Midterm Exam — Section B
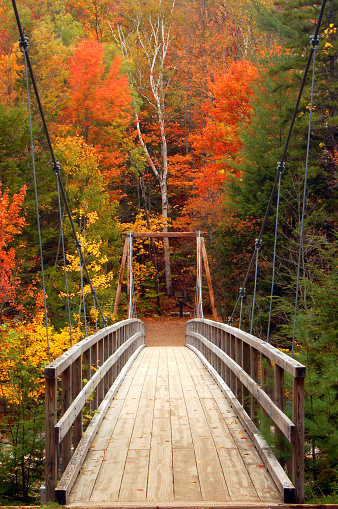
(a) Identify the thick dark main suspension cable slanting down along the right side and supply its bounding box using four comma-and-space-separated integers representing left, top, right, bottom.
228, 0, 326, 323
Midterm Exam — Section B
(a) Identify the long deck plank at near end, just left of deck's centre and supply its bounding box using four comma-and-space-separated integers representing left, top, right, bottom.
147, 418, 174, 502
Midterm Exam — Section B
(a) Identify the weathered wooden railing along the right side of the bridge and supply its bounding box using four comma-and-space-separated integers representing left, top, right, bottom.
186, 319, 306, 503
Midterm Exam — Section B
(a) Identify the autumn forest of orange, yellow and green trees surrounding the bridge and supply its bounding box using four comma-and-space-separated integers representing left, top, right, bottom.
0, 0, 338, 504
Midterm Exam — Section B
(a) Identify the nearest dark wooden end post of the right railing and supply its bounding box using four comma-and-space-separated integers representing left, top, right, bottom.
292, 377, 304, 504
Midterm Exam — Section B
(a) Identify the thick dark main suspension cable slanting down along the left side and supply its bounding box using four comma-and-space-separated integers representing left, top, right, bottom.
12, 0, 107, 325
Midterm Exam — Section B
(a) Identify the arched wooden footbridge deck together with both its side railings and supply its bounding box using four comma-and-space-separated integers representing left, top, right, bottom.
45, 318, 305, 508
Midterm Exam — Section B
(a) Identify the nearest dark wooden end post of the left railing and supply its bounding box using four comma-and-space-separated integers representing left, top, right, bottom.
45, 378, 57, 501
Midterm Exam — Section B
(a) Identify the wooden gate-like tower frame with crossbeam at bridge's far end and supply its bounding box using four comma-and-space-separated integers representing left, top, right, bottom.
114, 232, 218, 321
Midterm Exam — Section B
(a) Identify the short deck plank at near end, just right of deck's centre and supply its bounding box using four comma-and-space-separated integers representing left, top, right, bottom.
173, 448, 202, 502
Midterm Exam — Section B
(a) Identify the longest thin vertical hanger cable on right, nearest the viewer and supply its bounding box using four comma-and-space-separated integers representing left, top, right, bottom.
291, 35, 319, 357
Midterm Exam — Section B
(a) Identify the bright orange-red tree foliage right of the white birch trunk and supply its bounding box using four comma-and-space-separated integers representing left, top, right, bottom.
181, 60, 257, 229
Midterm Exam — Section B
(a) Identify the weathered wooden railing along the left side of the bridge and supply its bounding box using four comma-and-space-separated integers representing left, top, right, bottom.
45, 319, 145, 501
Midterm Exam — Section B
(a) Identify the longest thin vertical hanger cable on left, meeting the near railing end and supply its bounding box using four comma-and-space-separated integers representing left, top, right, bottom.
20, 41, 51, 362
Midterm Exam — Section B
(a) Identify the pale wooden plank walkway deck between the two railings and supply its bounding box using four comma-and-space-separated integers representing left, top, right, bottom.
68, 347, 282, 507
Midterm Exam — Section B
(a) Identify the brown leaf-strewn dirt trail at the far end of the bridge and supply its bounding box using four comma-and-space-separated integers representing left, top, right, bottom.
144, 317, 187, 346
